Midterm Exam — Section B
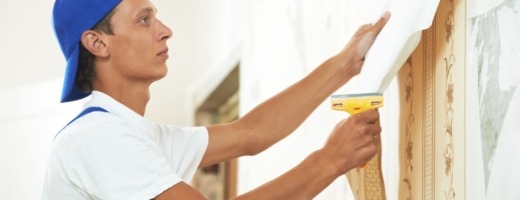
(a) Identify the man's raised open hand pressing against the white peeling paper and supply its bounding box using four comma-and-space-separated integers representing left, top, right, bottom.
335, 12, 390, 76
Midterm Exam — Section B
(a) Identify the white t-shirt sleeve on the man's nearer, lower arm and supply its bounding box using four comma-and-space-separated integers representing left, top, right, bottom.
68, 122, 182, 199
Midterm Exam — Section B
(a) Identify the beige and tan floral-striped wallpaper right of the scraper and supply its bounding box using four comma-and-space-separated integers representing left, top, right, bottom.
399, 0, 466, 199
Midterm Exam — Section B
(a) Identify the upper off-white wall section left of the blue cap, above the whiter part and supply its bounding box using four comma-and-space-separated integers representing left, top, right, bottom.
0, 0, 65, 89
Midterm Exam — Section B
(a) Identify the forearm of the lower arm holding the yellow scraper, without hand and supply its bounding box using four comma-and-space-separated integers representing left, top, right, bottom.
234, 150, 339, 200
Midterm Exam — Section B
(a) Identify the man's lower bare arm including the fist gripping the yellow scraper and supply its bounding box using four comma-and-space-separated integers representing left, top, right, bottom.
157, 111, 381, 200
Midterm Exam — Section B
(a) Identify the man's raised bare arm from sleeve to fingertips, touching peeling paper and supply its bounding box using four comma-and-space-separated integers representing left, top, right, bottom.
199, 12, 388, 167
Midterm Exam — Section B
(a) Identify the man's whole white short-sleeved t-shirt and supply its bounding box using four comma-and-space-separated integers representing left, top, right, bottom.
43, 91, 208, 199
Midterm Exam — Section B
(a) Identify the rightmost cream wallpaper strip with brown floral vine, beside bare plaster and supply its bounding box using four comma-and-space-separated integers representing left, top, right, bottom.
433, 0, 466, 200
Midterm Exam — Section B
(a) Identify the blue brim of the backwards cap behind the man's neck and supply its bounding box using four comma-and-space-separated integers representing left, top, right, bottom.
61, 45, 90, 103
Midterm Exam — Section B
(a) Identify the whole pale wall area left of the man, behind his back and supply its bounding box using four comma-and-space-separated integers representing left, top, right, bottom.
0, 0, 82, 199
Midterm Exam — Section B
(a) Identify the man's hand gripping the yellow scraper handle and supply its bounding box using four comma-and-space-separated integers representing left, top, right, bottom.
322, 110, 381, 175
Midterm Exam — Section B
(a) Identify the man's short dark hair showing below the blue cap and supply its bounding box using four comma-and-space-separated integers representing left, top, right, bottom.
74, 9, 115, 93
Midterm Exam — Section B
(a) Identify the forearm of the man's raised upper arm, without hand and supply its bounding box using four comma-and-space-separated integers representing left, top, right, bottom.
239, 57, 354, 154
